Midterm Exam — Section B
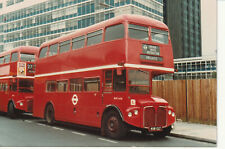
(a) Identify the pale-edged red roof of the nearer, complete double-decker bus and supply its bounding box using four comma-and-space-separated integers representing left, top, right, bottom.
41, 14, 168, 47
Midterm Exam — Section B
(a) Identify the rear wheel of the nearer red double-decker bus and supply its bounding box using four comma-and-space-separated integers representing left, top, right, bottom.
45, 104, 55, 125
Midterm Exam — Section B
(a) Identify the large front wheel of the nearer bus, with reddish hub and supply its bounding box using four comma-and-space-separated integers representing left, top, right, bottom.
103, 111, 127, 139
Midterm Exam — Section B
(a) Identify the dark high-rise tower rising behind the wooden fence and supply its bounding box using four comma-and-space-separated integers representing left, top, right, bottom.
164, 0, 202, 59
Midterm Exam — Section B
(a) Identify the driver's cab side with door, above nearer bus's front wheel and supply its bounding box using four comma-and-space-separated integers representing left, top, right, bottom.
102, 68, 126, 108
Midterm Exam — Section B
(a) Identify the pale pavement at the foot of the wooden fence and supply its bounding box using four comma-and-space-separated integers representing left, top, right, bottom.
171, 121, 217, 144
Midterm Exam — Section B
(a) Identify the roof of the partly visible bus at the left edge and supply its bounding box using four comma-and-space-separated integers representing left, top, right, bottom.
0, 46, 39, 57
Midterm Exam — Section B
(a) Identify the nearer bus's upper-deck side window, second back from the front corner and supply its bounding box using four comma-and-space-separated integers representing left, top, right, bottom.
87, 30, 102, 46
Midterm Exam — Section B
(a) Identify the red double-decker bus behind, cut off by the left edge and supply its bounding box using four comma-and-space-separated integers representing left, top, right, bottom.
0, 46, 39, 117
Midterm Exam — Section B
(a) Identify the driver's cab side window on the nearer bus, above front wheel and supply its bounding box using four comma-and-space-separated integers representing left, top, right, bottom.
113, 70, 126, 91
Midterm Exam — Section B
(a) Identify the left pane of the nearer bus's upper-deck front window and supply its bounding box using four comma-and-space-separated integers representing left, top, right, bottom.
128, 24, 149, 41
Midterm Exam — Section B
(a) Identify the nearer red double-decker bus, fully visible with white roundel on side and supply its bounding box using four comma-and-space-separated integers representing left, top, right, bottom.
33, 15, 175, 139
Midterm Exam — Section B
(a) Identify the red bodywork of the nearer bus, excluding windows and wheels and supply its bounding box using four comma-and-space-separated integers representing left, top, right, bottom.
33, 15, 175, 131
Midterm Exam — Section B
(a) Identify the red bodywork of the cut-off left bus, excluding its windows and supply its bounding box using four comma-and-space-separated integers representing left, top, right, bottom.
0, 46, 38, 112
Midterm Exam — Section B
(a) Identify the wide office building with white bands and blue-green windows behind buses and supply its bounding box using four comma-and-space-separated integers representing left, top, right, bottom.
0, 0, 163, 51
